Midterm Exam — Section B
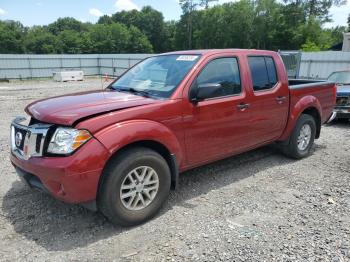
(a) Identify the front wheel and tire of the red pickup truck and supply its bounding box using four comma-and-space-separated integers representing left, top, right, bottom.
98, 147, 171, 226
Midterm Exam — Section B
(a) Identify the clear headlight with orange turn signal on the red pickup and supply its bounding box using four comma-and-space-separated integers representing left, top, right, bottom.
47, 127, 92, 155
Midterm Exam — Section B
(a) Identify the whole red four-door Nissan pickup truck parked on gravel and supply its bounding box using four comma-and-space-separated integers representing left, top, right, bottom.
11, 49, 336, 225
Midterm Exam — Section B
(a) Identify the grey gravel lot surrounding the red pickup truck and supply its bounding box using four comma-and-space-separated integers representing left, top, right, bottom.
0, 79, 350, 261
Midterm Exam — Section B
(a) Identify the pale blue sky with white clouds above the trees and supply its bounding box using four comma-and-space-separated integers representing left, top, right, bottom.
0, 0, 350, 27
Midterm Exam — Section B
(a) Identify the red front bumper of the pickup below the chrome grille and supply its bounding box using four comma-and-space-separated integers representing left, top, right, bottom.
11, 138, 109, 204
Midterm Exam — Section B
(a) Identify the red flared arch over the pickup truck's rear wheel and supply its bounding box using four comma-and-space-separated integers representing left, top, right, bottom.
279, 95, 322, 141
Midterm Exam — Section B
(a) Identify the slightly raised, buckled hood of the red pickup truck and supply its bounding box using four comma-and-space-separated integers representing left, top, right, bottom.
25, 90, 160, 126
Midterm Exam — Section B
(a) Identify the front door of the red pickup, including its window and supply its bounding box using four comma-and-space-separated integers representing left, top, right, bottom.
184, 57, 250, 166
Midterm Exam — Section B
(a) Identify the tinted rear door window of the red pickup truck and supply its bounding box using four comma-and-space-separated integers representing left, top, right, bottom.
248, 56, 278, 91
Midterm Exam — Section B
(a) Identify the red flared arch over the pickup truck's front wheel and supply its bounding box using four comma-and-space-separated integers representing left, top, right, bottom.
94, 120, 183, 163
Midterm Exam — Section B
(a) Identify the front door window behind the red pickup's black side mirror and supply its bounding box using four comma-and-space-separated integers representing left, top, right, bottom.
196, 57, 242, 98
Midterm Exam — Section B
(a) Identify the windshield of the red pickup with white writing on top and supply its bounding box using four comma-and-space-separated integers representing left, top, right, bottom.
111, 55, 200, 98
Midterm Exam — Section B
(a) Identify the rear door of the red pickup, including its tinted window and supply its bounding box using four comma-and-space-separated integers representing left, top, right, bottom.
248, 56, 289, 145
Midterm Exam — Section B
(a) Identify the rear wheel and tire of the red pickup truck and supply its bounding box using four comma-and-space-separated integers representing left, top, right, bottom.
282, 114, 316, 159
